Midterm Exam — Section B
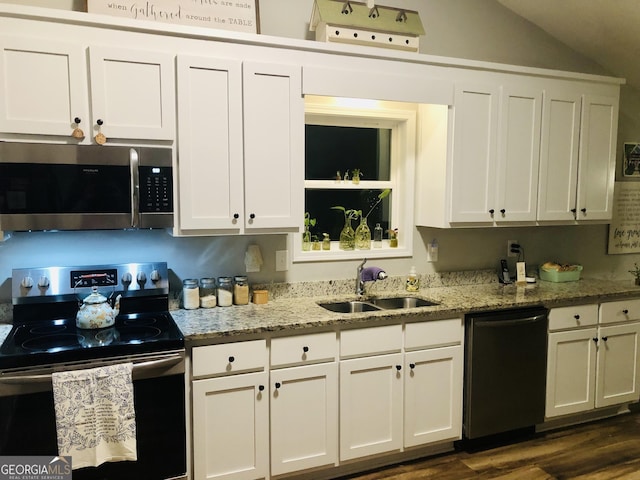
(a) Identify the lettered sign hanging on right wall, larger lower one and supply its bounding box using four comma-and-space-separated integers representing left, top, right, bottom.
608, 182, 640, 254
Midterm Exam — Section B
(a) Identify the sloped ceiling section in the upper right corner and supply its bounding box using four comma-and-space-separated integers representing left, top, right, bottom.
497, 0, 640, 90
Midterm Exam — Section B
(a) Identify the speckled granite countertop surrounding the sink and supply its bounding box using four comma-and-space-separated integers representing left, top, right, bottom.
171, 279, 640, 343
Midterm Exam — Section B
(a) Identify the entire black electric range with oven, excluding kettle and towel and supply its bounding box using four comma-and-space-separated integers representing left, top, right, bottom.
0, 262, 186, 480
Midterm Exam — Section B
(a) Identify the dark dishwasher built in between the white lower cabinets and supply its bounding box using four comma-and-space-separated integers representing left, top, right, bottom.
463, 307, 548, 440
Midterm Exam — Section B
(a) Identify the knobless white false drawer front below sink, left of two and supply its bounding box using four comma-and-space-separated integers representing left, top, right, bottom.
340, 325, 402, 358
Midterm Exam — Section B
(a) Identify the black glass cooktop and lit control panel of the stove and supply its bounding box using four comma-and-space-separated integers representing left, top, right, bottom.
0, 263, 184, 370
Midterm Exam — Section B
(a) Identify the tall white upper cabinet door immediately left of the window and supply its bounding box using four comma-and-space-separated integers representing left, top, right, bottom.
243, 62, 304, 232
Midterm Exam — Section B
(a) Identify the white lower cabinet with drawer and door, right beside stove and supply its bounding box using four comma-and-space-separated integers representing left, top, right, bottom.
192, 340, 269, 480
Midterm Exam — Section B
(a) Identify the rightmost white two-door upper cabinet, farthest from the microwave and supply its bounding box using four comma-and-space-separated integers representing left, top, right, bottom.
538, 86, 619, 223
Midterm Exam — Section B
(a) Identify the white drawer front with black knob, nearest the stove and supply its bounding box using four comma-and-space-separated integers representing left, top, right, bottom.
192, 340, 267, 377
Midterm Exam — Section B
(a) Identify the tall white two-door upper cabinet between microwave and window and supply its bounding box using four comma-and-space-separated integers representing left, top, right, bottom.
178, 55, 304, 235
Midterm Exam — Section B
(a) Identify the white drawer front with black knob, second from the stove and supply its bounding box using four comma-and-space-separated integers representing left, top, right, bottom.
271, 332, 337, 367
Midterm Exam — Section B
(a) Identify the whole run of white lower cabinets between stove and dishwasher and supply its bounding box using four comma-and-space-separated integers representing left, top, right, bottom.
192, 318, 463, 480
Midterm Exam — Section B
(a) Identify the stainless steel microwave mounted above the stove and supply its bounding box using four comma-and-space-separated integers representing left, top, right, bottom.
0, 142, 173, 231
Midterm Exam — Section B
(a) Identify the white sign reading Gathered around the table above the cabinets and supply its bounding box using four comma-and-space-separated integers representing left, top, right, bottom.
87, 0, 260, 33
